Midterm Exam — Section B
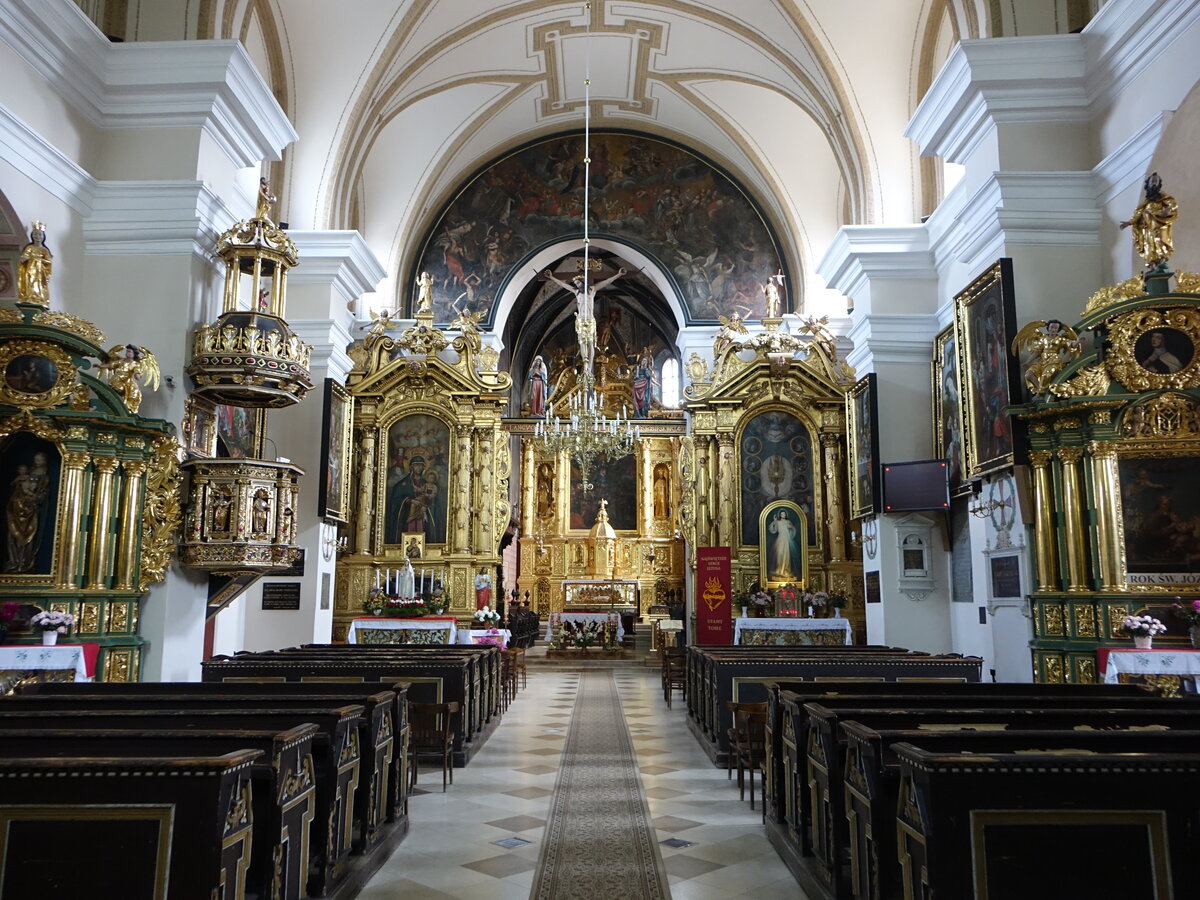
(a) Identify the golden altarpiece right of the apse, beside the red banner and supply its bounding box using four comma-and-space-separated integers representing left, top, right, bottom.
679, 318, 865, 634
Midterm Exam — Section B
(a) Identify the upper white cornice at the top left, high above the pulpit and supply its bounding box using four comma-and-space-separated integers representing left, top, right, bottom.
0, 0, 299, 168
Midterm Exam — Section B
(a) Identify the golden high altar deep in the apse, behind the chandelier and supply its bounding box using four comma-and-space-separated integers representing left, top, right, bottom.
511, 352, 685, 619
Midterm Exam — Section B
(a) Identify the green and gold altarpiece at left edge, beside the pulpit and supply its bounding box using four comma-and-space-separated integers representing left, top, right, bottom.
0, 243, 180, 694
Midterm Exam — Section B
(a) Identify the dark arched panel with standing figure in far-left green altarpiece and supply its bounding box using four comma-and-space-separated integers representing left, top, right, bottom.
0, 432, 61, 575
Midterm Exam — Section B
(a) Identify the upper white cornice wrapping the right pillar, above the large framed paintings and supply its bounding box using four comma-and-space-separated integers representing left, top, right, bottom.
905, 35, 1091, 162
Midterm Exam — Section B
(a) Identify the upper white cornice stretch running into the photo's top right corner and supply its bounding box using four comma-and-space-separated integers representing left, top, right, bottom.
1082, 0, 1200, 112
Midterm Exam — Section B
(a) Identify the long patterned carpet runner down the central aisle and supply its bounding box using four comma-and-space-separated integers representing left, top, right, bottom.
529, 671, 671, 900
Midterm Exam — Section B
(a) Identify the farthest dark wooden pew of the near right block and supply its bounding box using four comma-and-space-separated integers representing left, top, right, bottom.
763, 682, 1153, 841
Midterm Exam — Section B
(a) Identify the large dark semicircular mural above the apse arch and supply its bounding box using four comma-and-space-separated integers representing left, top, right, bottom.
409, 133, 790, 323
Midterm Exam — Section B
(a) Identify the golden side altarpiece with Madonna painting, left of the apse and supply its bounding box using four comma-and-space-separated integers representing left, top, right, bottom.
334, 308, 512, 641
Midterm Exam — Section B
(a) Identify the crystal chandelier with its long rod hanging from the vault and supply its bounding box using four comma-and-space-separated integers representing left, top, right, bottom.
534, 2, 641, 491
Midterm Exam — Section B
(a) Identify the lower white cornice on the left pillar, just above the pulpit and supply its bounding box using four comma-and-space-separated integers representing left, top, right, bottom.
83, 181, 236, 260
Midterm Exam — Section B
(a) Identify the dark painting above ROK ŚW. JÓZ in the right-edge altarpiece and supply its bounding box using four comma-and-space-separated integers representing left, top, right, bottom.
1118, 457, 1200, 575
